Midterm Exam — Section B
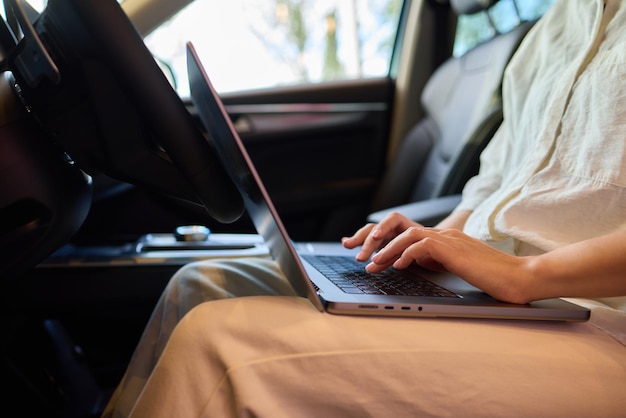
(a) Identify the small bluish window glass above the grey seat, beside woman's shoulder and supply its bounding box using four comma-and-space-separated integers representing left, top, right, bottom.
454, 0, 554, 56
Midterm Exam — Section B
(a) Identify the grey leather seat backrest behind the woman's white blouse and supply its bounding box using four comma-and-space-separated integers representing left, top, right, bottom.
372, 0, 533, 211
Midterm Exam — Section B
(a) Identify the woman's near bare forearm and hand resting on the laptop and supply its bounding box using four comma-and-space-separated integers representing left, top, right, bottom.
367, 227, 626, 303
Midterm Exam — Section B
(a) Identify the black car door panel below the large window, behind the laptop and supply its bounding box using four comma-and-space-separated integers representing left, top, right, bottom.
192, 74, 393, 240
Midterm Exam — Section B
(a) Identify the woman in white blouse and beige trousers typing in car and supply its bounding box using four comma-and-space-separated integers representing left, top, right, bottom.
106, 0, 626, 417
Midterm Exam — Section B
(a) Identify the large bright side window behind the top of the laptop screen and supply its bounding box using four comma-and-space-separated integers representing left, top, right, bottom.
145, 0, 402, 97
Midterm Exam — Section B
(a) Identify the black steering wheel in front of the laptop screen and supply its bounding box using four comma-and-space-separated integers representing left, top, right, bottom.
0, 0, 243, 223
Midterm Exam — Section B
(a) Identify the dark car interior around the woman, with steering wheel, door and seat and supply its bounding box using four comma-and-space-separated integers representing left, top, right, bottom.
0, 0, 545, 417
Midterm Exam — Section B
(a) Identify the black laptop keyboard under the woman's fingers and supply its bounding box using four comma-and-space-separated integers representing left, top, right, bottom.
302, 255, 459, 298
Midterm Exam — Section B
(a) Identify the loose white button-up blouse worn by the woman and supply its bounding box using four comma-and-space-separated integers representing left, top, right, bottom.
457, 0, 626, 342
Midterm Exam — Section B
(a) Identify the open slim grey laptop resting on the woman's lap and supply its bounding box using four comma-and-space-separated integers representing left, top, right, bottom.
187, 43, 590, 321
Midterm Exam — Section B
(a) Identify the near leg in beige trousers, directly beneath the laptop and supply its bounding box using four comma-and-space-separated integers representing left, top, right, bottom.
130, 297, 626, 417
